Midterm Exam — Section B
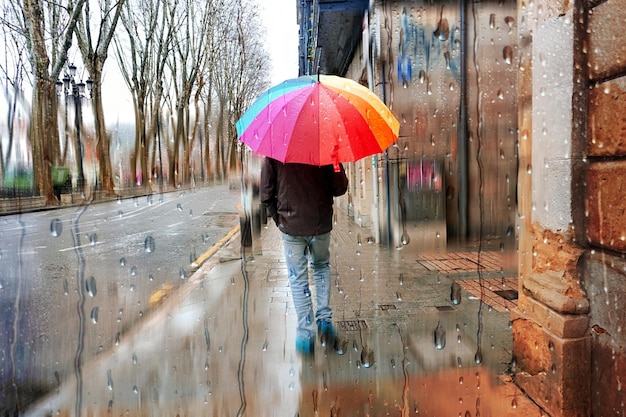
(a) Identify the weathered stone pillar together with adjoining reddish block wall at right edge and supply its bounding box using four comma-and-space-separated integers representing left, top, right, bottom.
512, 0, 626, 417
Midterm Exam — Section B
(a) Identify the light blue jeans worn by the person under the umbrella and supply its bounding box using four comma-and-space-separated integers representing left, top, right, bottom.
283, 232, 333, 337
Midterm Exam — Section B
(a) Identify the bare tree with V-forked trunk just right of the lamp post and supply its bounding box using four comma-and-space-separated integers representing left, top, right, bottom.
76, 0, 125, 195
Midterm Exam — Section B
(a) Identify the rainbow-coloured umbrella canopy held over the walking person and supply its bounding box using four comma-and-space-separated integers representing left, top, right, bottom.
237, 75, 400, 166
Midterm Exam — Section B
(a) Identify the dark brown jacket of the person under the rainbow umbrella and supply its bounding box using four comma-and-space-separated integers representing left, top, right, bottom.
260, 158, 348, 236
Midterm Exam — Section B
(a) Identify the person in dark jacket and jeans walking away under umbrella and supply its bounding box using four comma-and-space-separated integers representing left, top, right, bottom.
260, 157, 348, 355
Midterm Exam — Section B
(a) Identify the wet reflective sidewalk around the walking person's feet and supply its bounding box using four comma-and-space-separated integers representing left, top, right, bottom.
24, 206, 545, 417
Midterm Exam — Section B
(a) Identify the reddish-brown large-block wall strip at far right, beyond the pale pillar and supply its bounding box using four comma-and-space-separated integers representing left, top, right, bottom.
575, 0, 626, 416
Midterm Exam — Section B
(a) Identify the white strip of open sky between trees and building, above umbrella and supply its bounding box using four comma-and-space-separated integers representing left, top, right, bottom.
260, 0, 298, 85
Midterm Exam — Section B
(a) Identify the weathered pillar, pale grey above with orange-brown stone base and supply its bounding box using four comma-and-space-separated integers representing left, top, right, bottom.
511, 1, 591, 417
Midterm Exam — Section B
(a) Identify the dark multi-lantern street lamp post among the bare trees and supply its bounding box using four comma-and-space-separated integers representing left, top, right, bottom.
56, 64, 93, 194
